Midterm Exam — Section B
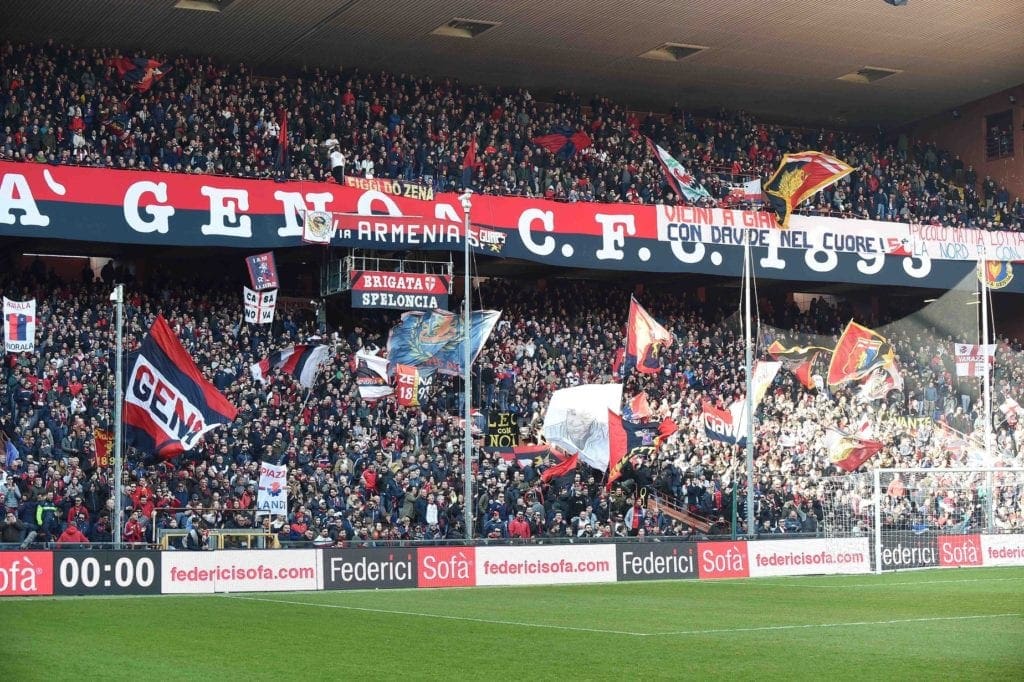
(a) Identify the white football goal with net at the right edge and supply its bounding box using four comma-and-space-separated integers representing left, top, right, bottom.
819, 468, 1024, 573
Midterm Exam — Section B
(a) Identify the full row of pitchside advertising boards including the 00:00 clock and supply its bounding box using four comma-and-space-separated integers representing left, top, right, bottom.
0, 534, 1024, 597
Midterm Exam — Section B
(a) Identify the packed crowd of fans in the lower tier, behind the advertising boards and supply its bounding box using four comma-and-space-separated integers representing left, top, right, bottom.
0, 260, 1024, 545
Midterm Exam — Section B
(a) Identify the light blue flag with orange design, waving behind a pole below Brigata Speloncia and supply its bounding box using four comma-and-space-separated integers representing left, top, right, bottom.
387, 310, 502, 375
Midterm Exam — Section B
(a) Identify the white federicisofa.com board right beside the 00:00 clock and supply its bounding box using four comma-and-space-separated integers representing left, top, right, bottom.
160, 549, 324, 594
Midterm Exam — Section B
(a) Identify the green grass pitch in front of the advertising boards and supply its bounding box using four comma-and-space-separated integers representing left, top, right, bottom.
0, 568, 1024, 681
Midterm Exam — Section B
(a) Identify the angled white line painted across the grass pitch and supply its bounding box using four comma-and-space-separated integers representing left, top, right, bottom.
222, 595, 1021, 637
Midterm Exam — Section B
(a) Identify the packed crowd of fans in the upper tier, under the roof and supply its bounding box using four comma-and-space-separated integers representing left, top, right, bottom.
0, 43, 1024, 230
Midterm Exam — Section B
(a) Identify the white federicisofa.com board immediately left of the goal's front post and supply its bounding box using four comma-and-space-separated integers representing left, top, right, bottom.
746, 538, 871, 578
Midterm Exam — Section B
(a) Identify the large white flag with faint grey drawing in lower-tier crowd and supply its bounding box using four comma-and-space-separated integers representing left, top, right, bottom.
543, 384, 623, 471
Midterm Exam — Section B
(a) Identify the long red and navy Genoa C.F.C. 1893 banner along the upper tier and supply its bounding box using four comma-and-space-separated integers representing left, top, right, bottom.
0, 162, 1024, 293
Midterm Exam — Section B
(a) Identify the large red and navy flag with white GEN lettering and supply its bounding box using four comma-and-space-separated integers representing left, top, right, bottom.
124, 315, 238, 460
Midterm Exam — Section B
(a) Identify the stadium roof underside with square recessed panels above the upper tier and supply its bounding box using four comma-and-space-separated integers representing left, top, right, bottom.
4, 0, 1024, 126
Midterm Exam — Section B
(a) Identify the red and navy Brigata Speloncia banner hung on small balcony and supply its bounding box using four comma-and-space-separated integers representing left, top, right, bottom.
350, 270, 451, 310
